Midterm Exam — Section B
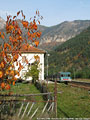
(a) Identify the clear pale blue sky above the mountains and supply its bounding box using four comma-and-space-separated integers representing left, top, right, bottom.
0, 0, 90, 26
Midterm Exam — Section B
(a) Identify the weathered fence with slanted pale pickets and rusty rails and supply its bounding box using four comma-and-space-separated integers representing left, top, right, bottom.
0, 79, 57, 120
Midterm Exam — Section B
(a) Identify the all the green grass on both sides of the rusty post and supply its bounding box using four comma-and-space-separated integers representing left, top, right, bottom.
2, 83, 90, 120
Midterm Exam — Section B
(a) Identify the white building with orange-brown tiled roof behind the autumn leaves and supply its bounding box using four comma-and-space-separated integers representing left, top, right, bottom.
15, 46, 45, 80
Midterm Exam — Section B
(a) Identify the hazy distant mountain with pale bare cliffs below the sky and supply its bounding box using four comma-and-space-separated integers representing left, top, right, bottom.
40, 20, 90, 50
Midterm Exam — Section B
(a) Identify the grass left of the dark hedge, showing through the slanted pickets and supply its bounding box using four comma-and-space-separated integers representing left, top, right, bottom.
0, 83, 48, 120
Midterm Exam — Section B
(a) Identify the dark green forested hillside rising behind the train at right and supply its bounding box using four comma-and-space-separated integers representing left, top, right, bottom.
45, 27, 90, 78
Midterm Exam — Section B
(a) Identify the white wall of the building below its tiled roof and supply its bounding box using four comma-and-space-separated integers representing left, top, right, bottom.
15, 53, 44, 80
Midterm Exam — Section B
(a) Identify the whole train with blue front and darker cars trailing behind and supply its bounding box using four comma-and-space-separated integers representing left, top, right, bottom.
49, 72, 72, 84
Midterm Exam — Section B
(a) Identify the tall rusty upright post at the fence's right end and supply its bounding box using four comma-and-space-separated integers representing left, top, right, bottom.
54, 77, 57, 118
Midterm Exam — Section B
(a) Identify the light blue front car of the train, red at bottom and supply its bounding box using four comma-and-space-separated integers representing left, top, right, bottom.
58, 72, 71, 83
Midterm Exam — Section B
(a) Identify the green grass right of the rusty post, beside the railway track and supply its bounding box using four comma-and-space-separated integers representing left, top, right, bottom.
48, 83, 90, 118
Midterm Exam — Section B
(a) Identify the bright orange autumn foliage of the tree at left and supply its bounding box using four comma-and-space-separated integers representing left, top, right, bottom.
0, 10, 42, 90
